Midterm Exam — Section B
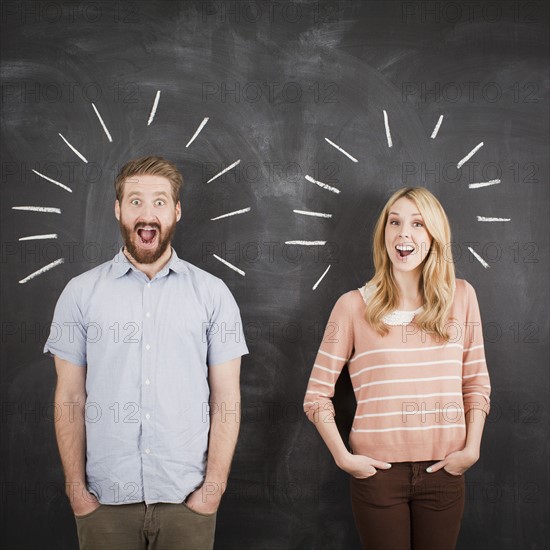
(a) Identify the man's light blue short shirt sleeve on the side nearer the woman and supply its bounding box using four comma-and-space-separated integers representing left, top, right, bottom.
206, 280, 248, 367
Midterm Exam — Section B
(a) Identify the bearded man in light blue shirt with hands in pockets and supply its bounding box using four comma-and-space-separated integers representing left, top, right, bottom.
44, 157, 248, 550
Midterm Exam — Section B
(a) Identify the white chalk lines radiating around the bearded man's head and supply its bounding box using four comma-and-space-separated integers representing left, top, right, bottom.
12, 90, 252, 284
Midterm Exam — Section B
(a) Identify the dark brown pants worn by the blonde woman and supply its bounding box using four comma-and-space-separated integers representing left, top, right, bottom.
351, 460, 465, 550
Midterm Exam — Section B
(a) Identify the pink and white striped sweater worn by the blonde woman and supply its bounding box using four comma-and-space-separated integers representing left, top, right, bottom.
304, 279, 490, 462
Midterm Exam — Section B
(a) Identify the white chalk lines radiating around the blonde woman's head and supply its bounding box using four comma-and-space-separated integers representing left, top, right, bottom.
292, 109, 511, 290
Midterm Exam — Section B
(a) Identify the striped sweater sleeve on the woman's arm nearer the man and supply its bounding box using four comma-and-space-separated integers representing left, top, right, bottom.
304, 293, 353, 421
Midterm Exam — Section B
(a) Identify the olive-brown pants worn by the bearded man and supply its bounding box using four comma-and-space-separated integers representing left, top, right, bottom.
75, 502, 216, 550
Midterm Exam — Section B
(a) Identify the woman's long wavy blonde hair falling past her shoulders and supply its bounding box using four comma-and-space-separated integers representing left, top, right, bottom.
365, 187, 455, 342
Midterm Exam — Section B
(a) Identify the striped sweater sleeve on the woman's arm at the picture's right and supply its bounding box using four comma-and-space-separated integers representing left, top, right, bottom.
462, 281, 491, 415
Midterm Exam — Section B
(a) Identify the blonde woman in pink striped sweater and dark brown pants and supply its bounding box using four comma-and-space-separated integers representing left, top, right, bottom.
304, 187, 490, 550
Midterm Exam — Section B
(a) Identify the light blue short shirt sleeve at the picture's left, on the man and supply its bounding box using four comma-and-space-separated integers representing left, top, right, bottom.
43, 280, 86, 367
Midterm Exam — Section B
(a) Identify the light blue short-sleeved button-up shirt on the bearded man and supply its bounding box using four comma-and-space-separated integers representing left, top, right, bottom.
44, 248, 248, 504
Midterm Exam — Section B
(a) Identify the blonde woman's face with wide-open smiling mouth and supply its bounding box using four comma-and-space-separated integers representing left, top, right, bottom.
385, 197, 432, 272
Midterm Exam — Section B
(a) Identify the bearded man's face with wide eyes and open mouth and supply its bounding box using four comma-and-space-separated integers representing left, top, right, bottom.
115, 175, 181, 264
